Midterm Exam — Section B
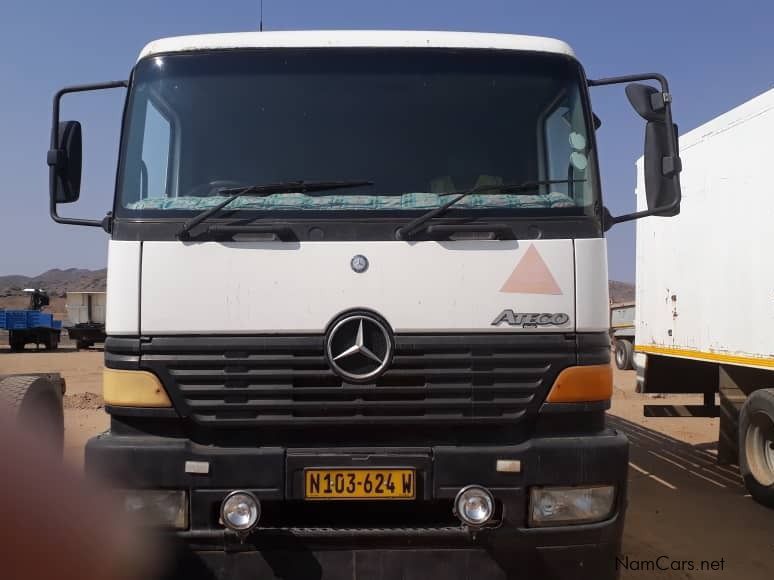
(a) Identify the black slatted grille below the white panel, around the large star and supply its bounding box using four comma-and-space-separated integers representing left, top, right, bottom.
140, 335, 575, 426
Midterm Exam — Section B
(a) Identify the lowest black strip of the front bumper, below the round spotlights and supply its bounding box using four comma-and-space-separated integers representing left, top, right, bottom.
166, 543, 619, 580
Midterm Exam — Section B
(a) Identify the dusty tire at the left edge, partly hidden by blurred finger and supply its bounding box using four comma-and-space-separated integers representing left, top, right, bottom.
0, 375, 64, 456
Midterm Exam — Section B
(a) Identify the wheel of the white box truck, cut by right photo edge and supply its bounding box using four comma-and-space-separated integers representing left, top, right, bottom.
739, 389, 774, 508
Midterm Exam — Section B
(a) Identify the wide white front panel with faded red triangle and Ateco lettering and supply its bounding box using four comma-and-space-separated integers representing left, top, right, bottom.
139, 240, 580, 335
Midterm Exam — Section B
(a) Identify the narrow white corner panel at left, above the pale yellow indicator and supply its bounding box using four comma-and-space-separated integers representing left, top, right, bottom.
105, 240, 142, 336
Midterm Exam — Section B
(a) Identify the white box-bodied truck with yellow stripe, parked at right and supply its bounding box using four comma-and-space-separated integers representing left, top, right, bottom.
635, 90, 774, 507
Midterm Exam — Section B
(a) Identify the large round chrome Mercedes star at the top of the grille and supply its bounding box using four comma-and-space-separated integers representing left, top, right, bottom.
325, 314, 392, 382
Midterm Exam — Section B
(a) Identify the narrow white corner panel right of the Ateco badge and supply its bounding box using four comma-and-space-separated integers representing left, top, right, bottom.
575, 238, 610, 332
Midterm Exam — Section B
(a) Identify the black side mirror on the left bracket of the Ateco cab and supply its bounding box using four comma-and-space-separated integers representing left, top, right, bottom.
46, 121, 83, 203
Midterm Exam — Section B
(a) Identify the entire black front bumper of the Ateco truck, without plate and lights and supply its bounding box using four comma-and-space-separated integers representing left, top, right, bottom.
86, 431, 628, 580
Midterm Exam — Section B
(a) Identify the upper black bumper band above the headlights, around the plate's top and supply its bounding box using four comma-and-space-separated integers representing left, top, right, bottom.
85, 431, 628, 499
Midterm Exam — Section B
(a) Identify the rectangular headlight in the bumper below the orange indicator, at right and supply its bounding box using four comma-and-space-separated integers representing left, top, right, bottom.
529, 485, 615, 527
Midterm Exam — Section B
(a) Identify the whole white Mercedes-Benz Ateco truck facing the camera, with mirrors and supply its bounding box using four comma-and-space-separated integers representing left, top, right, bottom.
48, 31, 679, 580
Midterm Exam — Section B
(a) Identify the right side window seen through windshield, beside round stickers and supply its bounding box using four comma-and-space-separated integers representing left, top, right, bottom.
543, 88, 591, 206
